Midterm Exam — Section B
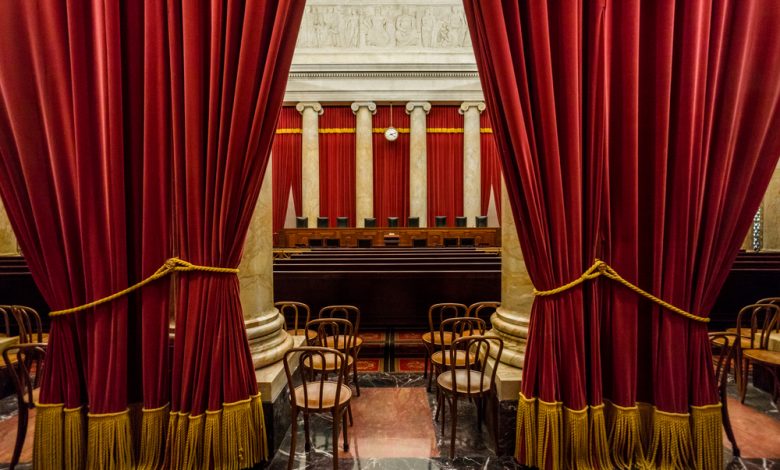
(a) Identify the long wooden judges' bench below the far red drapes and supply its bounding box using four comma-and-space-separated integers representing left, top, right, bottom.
277, 227, 501, 248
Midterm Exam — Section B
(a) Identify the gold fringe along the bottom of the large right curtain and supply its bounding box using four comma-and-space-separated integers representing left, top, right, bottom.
515, 393, 723, 470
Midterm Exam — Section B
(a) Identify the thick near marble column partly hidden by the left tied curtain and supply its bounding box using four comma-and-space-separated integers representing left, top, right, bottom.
238, 160, 293, 369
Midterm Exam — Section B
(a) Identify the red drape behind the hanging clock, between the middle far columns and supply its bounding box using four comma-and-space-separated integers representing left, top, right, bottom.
373, 105, 409, 226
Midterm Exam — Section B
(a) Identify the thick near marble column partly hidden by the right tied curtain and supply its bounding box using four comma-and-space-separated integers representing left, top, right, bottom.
490, 181, 534, 367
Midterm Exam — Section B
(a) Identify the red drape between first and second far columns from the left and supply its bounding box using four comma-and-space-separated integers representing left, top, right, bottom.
319, 106, 355, 227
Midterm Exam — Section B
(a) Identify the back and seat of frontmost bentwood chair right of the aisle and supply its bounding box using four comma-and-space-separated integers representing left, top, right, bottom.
449, 335, 504, 396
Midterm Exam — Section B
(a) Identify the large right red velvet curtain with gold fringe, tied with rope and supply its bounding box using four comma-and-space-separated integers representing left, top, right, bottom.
464, 0, 780, 468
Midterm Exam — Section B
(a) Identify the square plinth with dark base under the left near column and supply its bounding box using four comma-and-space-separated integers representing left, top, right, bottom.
255, 335, 304, 458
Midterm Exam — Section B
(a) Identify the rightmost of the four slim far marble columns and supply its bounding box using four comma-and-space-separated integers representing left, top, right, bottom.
458, 101, 485, 227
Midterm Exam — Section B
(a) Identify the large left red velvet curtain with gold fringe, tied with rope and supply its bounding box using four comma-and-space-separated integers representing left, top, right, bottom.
0, 1, 303, 468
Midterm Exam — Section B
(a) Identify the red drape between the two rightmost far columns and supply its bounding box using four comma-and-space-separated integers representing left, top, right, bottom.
426, 106, 463, 227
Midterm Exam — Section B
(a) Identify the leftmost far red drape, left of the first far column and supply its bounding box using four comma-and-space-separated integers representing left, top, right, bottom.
271, 106, 303, 233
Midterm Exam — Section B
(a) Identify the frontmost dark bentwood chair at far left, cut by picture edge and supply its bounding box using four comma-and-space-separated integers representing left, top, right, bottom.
3, 343, 46, 470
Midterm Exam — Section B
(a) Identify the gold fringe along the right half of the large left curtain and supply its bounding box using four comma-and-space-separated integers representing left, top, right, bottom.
165, 393, 268, 469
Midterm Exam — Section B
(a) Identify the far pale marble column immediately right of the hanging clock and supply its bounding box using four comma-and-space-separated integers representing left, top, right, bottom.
406, 101, 431, 227
